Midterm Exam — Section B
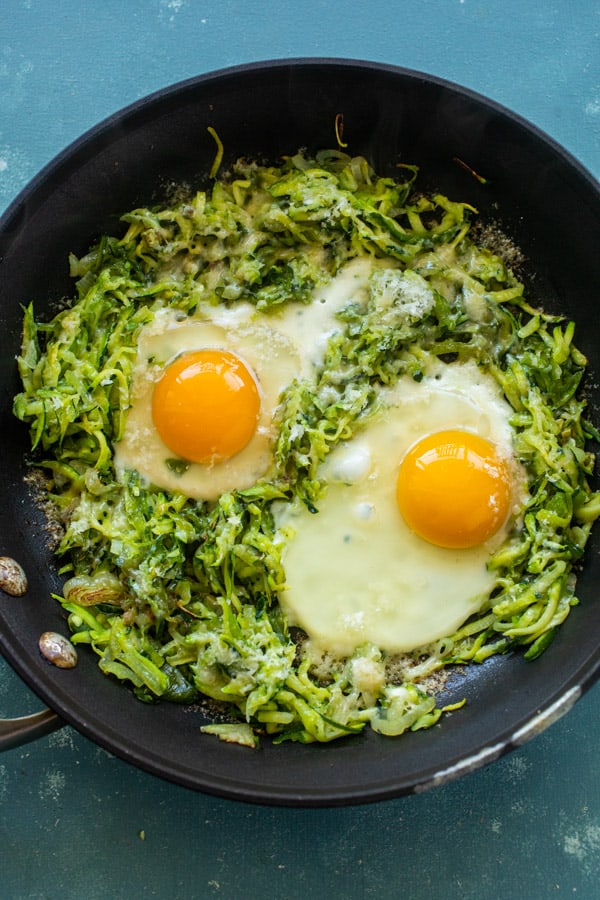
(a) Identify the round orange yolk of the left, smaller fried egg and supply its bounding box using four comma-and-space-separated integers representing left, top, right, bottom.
152, 349, 260, 464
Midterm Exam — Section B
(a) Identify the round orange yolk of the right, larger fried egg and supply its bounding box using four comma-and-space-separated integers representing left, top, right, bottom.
397, 430, 510, 548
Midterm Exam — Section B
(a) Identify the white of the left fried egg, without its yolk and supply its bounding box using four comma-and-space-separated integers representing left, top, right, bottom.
114, 259, 373, 500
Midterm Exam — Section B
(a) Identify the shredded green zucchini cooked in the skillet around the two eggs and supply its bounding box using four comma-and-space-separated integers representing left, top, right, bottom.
14, 151, 600, 746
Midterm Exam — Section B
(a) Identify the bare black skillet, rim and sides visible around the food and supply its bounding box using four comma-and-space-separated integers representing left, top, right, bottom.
0, 60, 600, 806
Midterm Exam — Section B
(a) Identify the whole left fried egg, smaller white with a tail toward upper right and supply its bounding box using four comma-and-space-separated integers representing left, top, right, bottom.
115, 259, 373, 500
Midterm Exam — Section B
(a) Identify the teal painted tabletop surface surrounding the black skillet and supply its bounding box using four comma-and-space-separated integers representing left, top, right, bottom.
0, 0, 600, 900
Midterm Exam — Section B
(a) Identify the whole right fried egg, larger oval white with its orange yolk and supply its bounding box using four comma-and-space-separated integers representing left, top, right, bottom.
277, 362, 526, 655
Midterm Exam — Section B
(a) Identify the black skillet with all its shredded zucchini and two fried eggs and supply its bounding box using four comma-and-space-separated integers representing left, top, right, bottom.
0, 60, 600, 806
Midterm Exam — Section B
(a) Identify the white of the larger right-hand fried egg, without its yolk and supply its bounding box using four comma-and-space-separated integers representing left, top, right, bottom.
277, 363, 525, 655
